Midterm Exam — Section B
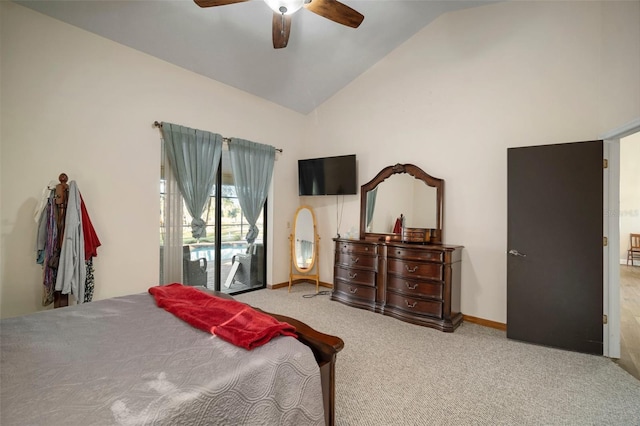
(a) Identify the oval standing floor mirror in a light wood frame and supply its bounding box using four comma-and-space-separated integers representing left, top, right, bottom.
289, 206, 320, 293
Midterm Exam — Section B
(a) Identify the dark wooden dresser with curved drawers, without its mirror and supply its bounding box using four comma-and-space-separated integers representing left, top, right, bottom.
331, 239, 462, 332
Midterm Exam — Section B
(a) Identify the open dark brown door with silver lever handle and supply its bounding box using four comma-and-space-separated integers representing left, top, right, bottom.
507, 141, 603, 355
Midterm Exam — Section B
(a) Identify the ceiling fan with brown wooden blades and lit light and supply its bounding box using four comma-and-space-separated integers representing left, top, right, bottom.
194, 0, 364, 49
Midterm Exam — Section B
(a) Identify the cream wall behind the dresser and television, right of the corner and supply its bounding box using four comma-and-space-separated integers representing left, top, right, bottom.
308, 2, 640, 323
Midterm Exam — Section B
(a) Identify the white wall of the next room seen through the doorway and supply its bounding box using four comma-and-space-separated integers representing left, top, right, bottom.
619, 132, 640, 265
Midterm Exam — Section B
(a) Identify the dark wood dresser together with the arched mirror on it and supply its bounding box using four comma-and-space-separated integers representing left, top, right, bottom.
331, 164, 463, 332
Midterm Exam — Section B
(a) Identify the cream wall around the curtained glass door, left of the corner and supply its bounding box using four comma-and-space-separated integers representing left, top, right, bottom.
0, 2, 305, 317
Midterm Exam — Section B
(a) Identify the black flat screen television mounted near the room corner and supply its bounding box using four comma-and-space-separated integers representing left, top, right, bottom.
298, 154, 358, 195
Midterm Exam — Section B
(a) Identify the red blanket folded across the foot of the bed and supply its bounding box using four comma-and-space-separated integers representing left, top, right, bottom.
149, 283, 296, 350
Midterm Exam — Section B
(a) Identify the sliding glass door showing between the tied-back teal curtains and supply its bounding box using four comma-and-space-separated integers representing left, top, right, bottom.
160, 146, 267, 294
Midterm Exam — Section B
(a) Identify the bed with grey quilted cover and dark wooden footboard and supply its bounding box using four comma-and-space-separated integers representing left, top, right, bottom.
0, 290, 344, 426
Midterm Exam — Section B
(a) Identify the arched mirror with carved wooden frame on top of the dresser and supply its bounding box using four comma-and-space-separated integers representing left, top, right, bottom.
360, 164, 444, 244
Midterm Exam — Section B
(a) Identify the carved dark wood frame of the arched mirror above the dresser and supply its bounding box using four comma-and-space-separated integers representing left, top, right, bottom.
360, 164, 444, 244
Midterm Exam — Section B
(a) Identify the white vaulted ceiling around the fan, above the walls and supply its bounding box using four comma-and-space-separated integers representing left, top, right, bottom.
15, 0, 494, 114
